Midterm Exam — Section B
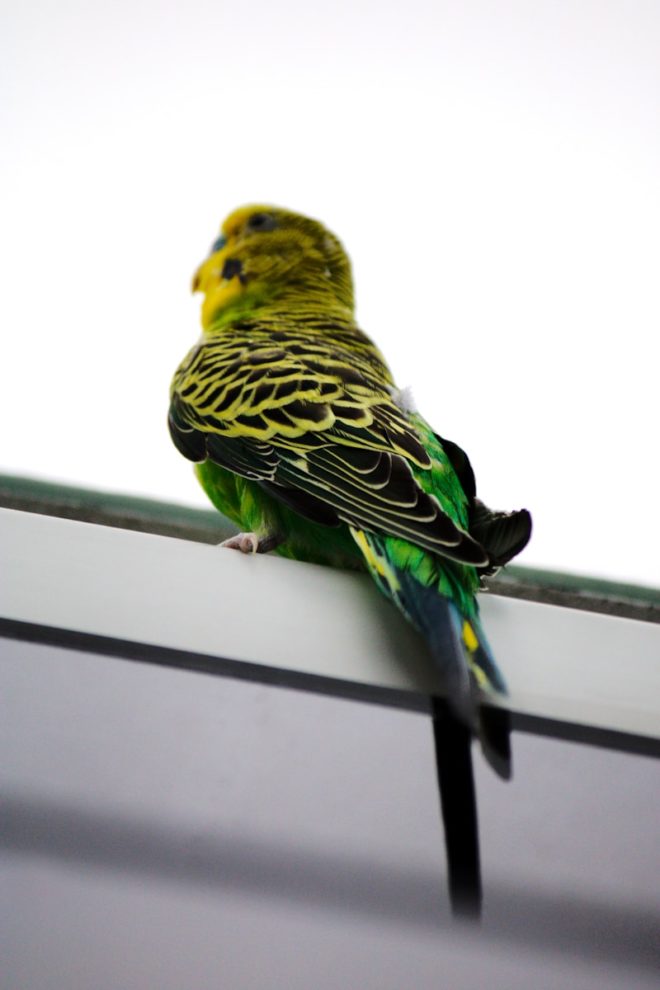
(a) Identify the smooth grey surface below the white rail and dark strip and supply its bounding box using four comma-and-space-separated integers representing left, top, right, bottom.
0, 640, 660, 990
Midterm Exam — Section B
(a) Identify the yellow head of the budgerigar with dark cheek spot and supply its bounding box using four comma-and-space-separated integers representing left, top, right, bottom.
192, 206, 353, 329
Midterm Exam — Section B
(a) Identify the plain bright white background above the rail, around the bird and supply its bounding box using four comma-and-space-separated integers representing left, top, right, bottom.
0, 0, 660, 584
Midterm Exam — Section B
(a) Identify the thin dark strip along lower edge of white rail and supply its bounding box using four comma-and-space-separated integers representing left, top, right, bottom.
0, 617, 660, 758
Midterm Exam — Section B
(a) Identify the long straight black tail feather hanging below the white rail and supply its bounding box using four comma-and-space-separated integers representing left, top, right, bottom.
432, 698, 481, 919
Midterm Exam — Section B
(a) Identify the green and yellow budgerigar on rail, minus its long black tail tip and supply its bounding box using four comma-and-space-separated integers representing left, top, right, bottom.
169, 206, 531, 776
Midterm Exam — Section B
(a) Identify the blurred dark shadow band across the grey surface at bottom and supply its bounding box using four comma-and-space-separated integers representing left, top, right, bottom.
1, 796, 660, 969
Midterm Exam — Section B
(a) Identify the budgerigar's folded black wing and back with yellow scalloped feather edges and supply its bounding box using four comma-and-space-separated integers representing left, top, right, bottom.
169, 327, 488, 566
